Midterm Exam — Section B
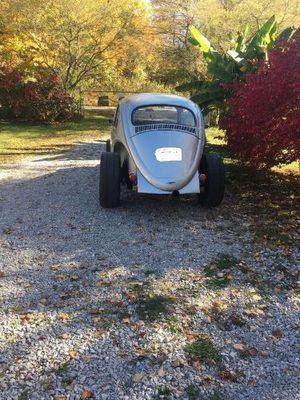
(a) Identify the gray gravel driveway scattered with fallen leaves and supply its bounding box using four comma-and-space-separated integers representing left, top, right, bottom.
0, 142, 300, 400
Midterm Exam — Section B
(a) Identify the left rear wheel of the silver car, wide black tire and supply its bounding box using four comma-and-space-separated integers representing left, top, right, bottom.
99, 152, 120, 208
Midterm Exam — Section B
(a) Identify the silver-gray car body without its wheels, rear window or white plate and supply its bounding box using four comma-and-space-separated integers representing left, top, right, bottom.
111, 93, 205, 194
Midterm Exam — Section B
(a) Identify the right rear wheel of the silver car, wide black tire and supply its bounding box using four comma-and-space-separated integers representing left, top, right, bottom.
199, 153, 225, 207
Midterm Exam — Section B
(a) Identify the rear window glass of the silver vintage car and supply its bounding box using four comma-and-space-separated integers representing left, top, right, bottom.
132, 105, 196, 127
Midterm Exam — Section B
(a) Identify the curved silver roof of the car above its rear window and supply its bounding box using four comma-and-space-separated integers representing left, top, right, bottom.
120, 93, 195, 109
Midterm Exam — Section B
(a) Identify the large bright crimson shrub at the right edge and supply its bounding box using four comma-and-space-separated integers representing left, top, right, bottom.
221, 35, 300, 168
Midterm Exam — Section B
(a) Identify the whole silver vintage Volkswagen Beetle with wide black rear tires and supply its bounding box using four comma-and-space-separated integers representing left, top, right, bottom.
99, 93, 225, 208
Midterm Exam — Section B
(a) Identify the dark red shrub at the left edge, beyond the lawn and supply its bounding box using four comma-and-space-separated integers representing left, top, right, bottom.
0, 60, 75, 123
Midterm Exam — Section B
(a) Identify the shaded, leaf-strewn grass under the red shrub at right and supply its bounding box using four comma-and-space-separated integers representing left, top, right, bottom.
207, 129, 300, 247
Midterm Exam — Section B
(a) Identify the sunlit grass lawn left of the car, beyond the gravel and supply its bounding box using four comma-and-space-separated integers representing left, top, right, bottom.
0, 113, 110, 165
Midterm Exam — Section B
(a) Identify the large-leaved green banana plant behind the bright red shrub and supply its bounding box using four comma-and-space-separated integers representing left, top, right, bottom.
180, 16, 286, 114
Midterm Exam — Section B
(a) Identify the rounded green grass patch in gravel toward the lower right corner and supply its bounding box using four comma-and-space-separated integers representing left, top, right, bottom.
184, 336, 221, 362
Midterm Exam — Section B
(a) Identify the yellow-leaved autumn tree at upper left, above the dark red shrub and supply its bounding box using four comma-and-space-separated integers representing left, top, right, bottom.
0, 0, 155, 92
